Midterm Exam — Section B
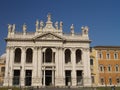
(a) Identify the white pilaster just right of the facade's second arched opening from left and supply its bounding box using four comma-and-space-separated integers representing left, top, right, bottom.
32, 47, 38, 86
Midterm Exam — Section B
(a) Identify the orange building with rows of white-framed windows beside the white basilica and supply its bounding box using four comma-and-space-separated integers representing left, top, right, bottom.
94, 46, 120, 86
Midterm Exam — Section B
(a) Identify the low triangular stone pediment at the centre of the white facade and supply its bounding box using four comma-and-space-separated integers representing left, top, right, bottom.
33, 33, 65, 40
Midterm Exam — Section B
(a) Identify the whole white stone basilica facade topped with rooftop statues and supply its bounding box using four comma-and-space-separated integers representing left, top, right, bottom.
4, 14, 91, 87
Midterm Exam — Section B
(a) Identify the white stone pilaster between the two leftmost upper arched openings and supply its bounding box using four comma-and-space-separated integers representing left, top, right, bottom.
20, 47, 26, 86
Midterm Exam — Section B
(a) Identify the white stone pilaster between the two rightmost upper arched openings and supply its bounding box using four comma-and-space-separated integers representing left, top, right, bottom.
71, 48, 76, 86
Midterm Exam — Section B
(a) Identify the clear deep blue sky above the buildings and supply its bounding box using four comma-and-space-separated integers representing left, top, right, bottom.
0, 0, 120, 55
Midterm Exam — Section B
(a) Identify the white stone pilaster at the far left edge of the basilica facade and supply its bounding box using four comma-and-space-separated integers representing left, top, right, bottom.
3, 47, 10, 86
